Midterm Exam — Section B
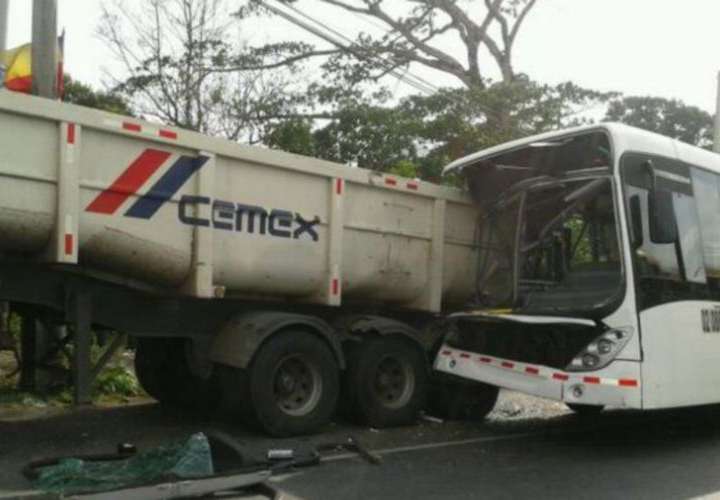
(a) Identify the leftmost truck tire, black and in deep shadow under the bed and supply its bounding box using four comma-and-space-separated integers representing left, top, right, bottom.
135, 337, 220, 411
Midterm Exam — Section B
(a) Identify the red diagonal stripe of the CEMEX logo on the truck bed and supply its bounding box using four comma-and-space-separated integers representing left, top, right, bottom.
85, 149, 170, 214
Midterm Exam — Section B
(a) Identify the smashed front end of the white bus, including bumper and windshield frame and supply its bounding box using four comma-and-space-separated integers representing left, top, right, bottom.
435, 127, 641, 411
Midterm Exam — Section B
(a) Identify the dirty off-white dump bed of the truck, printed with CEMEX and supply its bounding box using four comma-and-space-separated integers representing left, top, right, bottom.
0, 92, 484, 311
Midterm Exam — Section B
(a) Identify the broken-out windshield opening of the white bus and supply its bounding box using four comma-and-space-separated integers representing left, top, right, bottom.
464, 131, 622, 314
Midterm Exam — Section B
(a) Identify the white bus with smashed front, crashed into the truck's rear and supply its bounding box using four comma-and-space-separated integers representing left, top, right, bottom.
435, 124, 720, 413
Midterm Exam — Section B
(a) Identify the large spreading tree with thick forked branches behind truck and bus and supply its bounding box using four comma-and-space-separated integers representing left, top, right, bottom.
246, 0, 614, 180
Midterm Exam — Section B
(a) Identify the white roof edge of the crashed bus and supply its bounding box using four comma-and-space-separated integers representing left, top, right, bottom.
443, 122, 720, 174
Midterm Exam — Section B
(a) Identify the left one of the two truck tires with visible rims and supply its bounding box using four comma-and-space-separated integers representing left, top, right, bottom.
223, 330, 340, 437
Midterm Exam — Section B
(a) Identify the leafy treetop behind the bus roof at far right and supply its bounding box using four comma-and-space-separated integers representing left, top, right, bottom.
605, 96, 713, 148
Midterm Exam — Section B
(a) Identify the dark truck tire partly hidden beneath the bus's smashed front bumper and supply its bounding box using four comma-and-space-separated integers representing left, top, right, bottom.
428, 375, 500, 421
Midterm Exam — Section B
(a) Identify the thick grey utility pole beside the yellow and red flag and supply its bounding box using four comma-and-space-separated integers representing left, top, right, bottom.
32, 0, 58, 99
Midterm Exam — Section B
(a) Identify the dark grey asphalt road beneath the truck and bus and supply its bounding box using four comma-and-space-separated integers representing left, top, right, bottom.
0, 394, 720, 500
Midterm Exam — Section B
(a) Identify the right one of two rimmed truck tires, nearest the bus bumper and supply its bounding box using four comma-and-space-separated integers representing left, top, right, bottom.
343, 336, 428, 428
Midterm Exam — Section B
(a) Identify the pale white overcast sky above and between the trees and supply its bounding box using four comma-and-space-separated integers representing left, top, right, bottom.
8, 0, 720, 112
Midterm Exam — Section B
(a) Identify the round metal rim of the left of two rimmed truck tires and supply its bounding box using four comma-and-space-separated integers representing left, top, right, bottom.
273, 354, 322, 417
